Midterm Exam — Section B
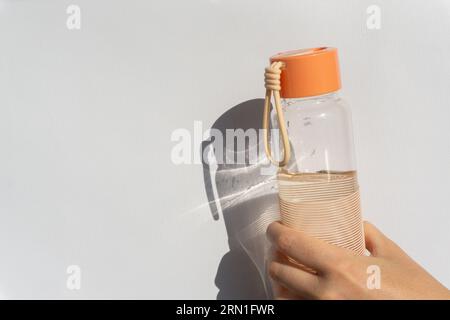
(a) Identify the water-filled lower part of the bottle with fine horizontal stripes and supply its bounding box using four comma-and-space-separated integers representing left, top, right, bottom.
278, 171, 365, 254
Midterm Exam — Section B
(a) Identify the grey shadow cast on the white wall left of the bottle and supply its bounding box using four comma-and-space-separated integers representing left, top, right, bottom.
201, 99, 278, 299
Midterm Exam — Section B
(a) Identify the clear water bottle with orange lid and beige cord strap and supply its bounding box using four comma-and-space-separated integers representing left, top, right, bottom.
263, 47, 365, 254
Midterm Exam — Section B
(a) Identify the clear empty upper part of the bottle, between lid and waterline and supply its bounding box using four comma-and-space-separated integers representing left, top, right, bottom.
282, 92, 356, 173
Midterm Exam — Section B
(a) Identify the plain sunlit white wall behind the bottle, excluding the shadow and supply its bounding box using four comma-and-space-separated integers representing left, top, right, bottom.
0, 0, 450, 298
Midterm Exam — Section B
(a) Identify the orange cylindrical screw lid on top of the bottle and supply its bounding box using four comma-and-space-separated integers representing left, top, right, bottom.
270, 47, 341, 98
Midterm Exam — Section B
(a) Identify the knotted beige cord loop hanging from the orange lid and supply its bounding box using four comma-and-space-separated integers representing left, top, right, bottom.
262, 61, 291, 167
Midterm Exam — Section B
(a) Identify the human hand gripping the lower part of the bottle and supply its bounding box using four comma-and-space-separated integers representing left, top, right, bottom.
267, 222, 450, 299
